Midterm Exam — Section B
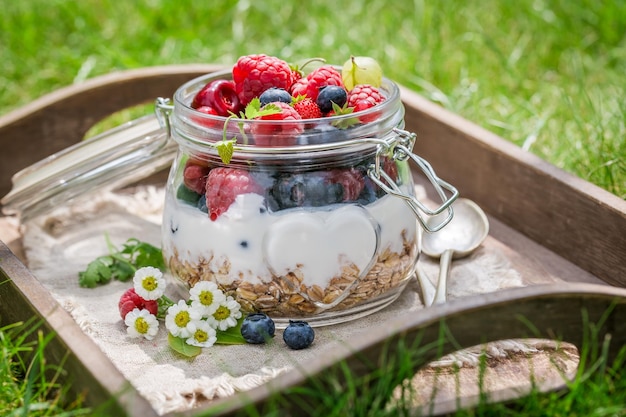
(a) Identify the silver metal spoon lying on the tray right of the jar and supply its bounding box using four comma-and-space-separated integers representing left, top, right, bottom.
417, 198, 489, 306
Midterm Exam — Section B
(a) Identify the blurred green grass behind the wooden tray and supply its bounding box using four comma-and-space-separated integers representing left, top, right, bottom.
0, 0, 626, 198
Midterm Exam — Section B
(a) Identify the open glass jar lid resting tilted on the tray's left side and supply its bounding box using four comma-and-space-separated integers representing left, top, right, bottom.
0, 115, 177, 221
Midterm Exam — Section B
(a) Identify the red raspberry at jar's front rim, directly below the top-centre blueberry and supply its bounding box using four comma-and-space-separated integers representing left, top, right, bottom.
250, 101, 304, 146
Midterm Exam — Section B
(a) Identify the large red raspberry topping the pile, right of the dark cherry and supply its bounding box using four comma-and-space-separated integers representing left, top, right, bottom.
233, 54, 293, 107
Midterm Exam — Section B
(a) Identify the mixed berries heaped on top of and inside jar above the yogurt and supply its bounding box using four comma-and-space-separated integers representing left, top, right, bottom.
177, 54, 392, 220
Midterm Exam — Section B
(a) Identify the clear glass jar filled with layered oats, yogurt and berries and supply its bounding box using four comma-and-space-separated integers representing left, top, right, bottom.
157, 72, 457, 326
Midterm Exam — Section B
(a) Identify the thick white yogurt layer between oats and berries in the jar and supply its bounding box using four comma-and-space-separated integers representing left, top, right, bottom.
163, 193, 417, 288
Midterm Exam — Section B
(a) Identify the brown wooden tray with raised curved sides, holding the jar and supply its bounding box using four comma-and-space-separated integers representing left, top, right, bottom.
0, 65, 626, 417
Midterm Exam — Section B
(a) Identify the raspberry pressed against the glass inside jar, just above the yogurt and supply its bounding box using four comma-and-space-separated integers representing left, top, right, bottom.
206, 167, 263, 221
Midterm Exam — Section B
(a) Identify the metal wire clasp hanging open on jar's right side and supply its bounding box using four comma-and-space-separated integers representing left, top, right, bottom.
368, 128, 459, 233
